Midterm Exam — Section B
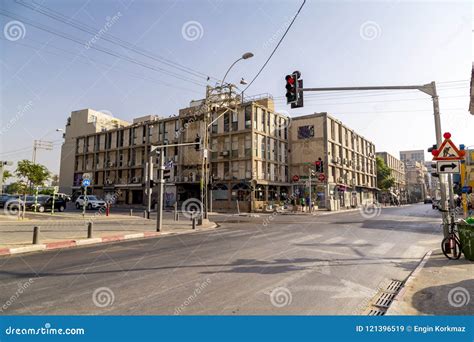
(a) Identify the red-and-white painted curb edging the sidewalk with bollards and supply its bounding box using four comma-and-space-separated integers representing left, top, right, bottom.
0, 223, 219, 257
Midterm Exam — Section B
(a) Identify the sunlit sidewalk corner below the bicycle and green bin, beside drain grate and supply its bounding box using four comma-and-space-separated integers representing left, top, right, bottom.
386, 249, 474, 315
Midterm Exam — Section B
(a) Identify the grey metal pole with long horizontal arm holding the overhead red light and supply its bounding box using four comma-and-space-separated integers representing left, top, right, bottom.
299, 82, 448, 228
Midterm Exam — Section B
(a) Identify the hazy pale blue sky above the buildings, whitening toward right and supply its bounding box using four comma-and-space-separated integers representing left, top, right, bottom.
0, 0, 474, 173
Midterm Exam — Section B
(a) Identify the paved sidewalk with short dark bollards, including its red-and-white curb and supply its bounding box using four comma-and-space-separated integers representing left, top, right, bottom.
0, 214, 217, 256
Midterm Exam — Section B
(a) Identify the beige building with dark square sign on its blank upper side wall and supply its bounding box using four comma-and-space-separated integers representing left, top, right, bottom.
290, 113, 377, 210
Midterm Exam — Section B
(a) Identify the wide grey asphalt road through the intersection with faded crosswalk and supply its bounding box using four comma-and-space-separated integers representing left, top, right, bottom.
0, 204, 441, 315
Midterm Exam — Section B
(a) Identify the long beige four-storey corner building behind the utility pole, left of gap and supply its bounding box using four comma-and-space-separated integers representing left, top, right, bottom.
61, 97, 290, 210
